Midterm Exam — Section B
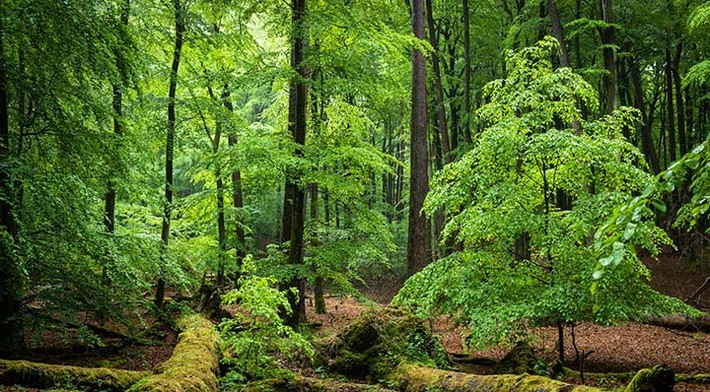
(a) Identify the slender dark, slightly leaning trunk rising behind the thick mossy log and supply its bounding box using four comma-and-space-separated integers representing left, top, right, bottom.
155, 0, 185, 307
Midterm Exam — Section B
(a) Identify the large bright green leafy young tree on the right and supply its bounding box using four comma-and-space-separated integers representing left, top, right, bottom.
395, 38, 700, 347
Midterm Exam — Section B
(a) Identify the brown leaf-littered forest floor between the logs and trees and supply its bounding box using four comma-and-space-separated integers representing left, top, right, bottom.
2, 251, 710, 392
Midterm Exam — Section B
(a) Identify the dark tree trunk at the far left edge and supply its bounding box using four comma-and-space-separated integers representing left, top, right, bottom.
0, 19, 25, 358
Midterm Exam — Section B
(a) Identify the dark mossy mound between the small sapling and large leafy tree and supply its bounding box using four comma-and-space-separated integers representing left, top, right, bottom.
321, 307, 450, 381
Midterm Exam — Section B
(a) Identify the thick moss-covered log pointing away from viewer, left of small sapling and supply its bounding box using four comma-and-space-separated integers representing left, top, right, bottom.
130, 315, 219, 392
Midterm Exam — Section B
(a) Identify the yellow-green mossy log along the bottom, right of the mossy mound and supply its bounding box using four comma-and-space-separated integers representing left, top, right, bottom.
392, 363, 601, 392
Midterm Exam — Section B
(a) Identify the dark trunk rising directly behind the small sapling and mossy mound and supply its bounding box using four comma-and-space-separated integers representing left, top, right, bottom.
284, 0, 308, 326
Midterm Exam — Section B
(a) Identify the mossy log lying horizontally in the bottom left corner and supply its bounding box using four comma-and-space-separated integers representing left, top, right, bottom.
0, 359, 150, 391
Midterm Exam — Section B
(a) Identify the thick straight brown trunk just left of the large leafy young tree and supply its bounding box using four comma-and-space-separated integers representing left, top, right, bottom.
407, 0, 429, 275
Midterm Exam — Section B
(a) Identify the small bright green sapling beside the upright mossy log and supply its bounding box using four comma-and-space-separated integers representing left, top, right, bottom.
219, 259, 313, 383
